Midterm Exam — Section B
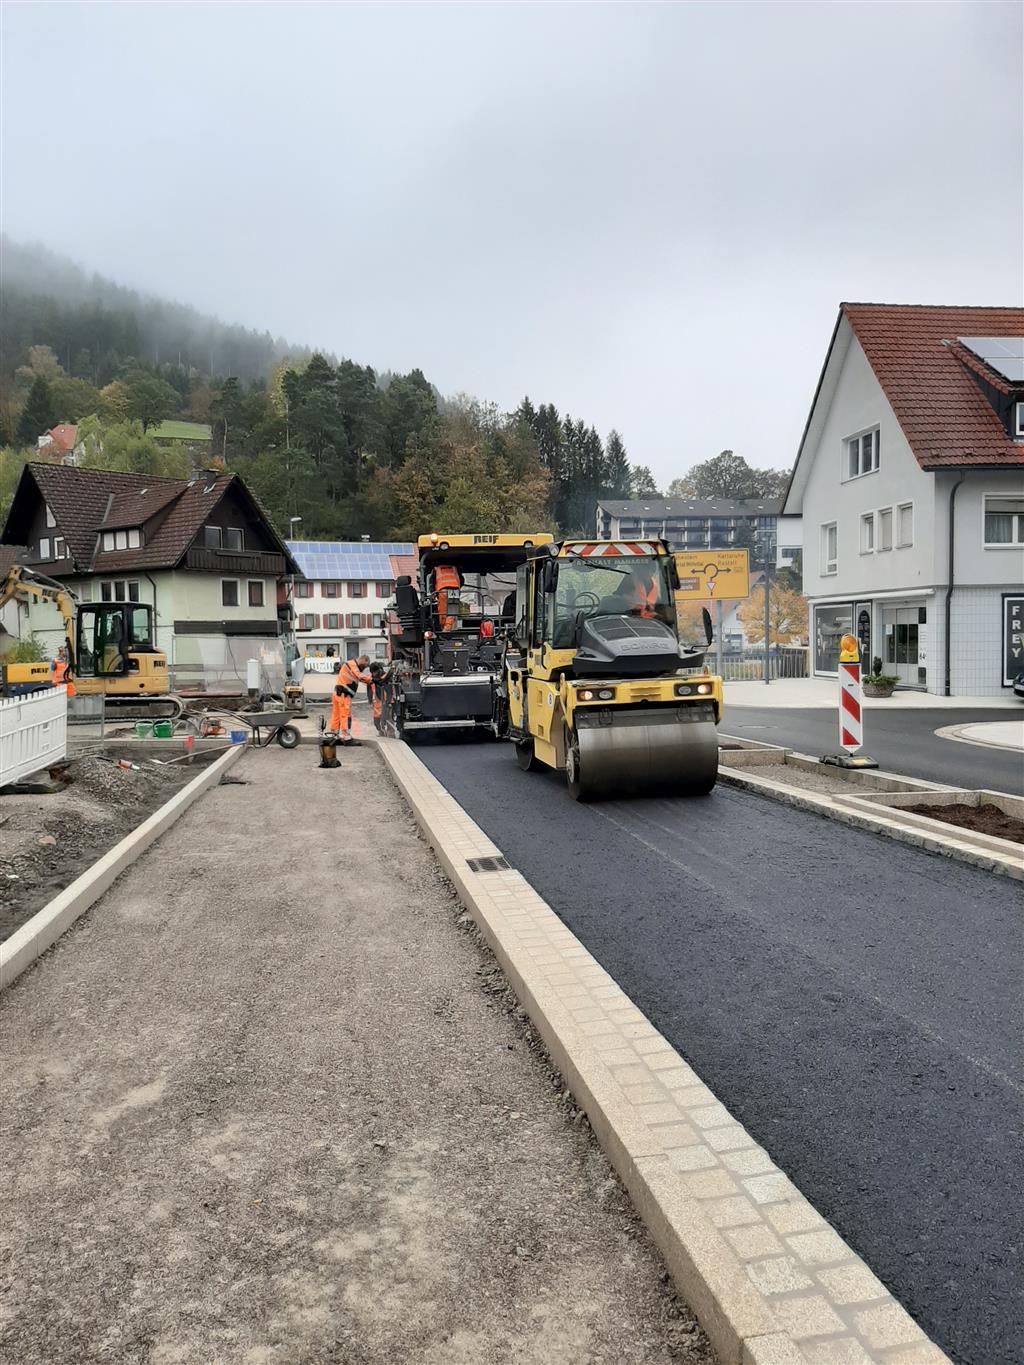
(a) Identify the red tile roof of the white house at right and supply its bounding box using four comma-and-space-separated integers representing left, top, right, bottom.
842, 303, 1024, 470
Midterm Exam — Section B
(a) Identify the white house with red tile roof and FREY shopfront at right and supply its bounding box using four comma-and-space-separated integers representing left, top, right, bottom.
784, 303, 1024, 696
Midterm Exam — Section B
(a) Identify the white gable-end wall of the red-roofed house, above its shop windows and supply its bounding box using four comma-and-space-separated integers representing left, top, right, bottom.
803, 339, 935, 598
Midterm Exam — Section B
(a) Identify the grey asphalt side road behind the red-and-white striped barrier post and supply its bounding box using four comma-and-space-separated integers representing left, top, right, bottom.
722, 696, 1024, 796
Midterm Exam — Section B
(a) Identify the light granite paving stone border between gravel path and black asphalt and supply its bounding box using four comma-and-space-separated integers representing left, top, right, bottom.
378, 740, 948, 1365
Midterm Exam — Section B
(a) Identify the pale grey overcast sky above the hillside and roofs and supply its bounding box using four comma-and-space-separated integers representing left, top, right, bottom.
0, 0, 1023, 483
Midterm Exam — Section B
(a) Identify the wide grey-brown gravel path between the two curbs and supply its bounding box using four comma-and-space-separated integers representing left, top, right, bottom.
0, 747, 713, 1365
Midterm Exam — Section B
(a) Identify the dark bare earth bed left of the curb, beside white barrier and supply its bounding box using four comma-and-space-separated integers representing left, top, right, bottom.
0, 751, 210, 942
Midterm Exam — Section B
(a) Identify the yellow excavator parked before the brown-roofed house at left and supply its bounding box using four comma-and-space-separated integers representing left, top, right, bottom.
0, 564, 183, 719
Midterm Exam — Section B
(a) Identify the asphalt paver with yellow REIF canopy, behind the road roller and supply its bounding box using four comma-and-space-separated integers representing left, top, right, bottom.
388, 532, 553, 738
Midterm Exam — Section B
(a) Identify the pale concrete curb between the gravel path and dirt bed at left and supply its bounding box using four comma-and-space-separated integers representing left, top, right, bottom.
0, 744, 246, 991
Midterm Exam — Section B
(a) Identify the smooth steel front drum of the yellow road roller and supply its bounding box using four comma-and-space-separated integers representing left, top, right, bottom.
565, 706, 718, 801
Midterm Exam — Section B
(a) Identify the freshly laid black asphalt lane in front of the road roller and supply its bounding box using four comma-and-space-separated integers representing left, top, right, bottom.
416, 737, 1024, 1365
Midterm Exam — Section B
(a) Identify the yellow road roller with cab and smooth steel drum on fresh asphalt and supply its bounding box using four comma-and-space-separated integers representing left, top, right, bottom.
494, 541, 722, 801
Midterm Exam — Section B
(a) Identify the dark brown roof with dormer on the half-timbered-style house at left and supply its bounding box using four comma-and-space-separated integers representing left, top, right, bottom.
3, 461, 296, 572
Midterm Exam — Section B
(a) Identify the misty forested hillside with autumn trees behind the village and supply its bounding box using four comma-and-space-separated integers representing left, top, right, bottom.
0, 239, 786, 539
